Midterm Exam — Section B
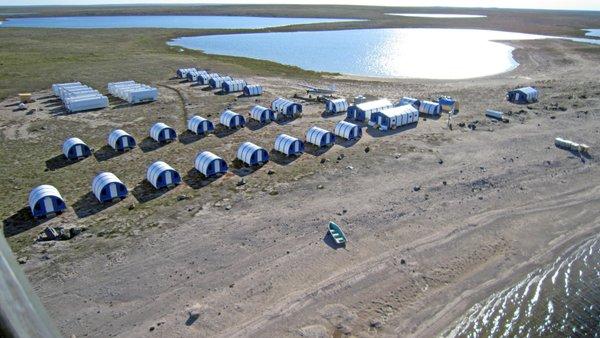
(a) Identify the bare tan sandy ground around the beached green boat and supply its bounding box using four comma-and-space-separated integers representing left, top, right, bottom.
2, 40, 600, 337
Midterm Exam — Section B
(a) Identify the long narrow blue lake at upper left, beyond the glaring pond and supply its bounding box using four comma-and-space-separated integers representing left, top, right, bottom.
0, 15, 352, 29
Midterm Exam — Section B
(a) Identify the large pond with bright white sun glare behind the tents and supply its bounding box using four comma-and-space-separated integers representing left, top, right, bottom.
169, 29, 543, 79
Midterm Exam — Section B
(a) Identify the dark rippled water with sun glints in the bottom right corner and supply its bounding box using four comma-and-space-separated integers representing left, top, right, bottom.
443, 235, 600, 337
